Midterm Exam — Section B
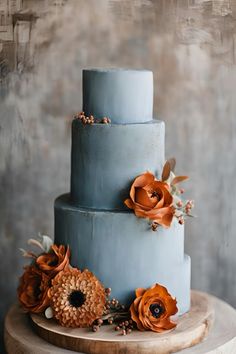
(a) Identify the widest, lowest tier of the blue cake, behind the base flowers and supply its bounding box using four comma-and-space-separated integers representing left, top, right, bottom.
55, 195, 191, 314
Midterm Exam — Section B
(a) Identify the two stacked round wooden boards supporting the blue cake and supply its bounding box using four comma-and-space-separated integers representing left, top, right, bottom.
5, 291, 236, 354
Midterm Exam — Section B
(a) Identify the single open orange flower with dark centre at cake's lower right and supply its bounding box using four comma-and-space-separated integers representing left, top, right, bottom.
130, 284, 178, 333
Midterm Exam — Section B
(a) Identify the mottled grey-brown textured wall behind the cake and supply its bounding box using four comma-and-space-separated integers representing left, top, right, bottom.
0, 0, 236, 352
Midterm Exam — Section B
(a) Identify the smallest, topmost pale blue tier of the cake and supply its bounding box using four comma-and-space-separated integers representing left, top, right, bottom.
83, 69, 153, 124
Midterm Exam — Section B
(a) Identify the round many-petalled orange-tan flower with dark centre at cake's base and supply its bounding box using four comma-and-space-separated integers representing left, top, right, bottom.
49, 268, 106, 327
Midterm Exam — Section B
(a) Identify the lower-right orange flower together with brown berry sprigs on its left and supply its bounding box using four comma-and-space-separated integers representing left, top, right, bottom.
92, 284, 178, 335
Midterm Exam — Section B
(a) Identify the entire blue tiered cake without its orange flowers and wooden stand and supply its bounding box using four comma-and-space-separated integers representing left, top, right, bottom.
55, 69, 190, 314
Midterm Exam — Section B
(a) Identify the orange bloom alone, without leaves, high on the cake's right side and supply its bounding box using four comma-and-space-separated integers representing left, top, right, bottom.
125, 172, 174, 227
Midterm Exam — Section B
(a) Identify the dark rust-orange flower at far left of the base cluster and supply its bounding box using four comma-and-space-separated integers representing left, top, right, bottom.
18, 266, 50, 313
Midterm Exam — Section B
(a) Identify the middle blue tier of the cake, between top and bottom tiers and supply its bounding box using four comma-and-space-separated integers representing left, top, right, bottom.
71, 119, 165, 210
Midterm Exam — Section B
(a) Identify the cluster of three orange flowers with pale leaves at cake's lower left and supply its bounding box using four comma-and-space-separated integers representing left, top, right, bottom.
18, 236, 107, 327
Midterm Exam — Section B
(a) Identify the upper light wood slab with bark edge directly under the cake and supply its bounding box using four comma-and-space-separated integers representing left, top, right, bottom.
31, 291, 214, 354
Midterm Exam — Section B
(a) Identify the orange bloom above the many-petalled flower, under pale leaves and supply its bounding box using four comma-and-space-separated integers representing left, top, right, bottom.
36, 245, 70, 277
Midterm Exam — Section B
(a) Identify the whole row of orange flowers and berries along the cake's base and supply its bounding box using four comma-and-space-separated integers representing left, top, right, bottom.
18, 236, 178, 335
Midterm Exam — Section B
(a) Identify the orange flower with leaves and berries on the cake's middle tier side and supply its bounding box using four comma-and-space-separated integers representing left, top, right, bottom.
124, 158, 193, 231
